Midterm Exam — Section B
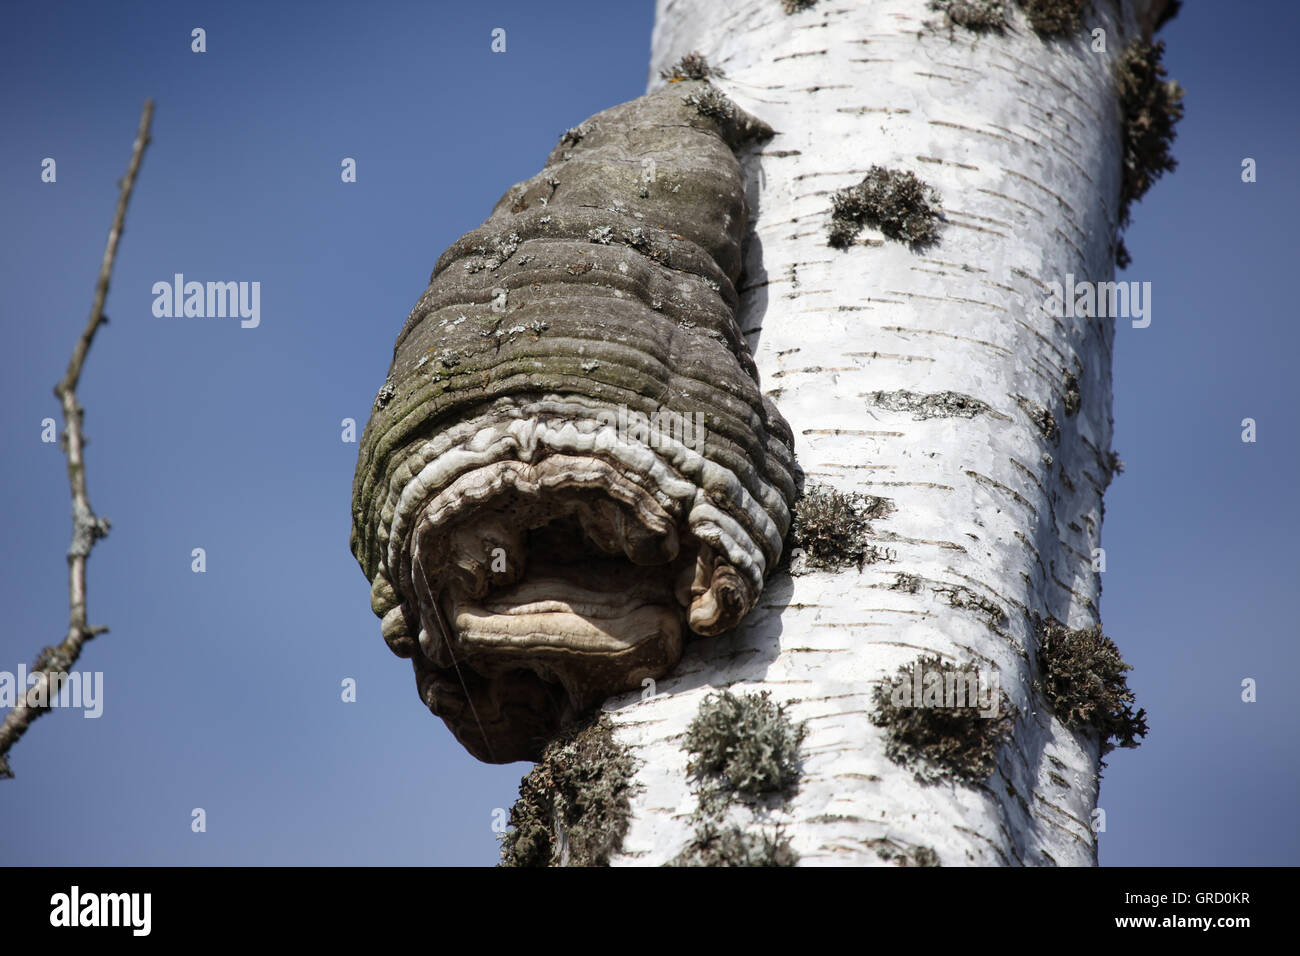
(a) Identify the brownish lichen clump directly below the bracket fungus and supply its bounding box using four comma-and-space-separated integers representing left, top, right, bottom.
501, 714, 636, 866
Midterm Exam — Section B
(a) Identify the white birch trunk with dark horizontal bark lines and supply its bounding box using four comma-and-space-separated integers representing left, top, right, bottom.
606, 0, 1151, 865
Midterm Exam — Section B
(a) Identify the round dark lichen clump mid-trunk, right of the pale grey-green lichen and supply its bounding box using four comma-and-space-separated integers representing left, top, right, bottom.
871, 656, 1015, 783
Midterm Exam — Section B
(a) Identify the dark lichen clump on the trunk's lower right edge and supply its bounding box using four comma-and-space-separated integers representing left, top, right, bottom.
1035, 618, 1147, 754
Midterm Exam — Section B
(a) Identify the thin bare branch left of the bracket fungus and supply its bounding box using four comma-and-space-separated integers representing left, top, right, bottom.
0, 100, 153, 779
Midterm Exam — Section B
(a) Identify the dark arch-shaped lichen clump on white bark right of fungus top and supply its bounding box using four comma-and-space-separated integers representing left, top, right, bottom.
827, 166, 940, 248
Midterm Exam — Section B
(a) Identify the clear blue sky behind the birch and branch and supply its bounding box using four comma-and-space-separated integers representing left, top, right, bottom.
0, 0, 1300, 865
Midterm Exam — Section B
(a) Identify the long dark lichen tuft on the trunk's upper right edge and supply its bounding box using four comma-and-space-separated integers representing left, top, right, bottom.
1115, 40, 1184, 268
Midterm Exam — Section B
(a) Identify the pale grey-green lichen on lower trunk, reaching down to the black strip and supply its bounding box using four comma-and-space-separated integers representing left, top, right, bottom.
668, 691, 807, 866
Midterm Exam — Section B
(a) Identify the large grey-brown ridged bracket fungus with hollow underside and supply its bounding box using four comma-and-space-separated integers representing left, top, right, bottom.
352, 82, 796, 762
